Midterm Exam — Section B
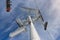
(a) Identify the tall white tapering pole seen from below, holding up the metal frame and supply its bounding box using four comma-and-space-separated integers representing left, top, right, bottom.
29, 16, 41, 40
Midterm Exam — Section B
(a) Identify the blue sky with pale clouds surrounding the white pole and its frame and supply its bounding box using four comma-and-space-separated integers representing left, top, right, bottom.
0, 0, 60, 40
